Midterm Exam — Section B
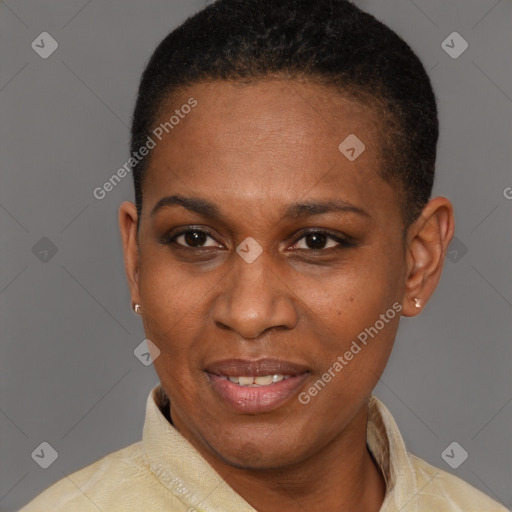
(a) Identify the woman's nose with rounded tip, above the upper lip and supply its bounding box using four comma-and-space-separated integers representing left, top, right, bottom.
213, 253, 298, 339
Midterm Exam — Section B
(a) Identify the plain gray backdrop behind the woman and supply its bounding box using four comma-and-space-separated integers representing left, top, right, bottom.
0, 0, 512, 512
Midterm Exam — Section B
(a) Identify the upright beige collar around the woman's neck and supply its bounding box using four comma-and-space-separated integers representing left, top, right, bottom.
142, 384, 418, 512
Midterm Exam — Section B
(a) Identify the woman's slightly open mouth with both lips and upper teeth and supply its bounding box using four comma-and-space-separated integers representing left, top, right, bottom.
205, 359, 311, 414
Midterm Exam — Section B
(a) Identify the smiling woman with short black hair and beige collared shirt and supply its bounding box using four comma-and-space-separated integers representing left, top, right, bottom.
19, 0, 505, 512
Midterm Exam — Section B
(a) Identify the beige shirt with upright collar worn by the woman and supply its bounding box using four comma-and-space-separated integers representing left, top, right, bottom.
20, 385, 507, 512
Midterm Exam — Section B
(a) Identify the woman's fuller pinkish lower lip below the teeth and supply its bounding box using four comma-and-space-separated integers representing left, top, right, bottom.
207, 372, 309, 414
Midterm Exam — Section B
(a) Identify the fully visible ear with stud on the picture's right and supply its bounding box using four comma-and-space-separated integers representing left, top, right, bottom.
402, 197, 455, 316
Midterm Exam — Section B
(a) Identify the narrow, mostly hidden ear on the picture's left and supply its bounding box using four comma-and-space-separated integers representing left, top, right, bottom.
118, 201, 140, 306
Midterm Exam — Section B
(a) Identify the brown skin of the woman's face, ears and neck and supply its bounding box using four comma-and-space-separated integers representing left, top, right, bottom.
119, 80, 454, 512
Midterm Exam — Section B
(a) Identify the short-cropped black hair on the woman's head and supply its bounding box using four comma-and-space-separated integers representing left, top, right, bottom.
131, 0, 439, 227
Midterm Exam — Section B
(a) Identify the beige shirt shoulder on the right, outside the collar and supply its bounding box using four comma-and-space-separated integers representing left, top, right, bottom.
408, 453, 508, 512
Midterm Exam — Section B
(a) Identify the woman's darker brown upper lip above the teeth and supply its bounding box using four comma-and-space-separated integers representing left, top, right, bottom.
205, 358, 309, 377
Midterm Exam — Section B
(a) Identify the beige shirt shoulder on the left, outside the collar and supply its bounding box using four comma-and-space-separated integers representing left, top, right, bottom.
20, 442, 184, 512
